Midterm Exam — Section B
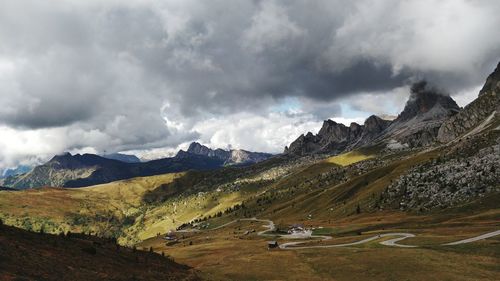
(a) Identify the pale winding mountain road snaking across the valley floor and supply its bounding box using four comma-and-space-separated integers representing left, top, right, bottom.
196, 218, 500, 250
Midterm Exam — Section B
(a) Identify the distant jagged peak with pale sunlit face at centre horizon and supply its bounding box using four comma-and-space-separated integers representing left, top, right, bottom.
180, 142, 272, 165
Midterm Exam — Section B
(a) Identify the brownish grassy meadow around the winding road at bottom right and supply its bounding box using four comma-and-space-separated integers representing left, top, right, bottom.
140, 212, 500, 281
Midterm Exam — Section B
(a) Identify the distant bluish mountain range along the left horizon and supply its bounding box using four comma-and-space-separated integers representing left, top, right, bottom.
0, 143, 272, 189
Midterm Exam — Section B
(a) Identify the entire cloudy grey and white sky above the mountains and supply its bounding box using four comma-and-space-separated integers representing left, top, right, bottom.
0, 0, 500, 170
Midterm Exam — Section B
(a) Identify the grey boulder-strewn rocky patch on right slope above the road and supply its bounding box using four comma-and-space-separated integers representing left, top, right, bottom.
381, 140, 500, 211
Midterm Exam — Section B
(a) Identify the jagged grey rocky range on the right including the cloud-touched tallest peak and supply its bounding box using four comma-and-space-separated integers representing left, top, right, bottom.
284, 77, 470, 155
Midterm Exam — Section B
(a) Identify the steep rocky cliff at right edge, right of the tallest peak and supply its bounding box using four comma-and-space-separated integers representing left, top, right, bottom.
437, 63, 500, 143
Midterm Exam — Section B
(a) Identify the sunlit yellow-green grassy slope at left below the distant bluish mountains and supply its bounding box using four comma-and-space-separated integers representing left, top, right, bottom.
0, 164, 272, 245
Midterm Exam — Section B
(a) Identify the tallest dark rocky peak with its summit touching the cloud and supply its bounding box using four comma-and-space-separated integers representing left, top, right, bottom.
396, 80, 460, 122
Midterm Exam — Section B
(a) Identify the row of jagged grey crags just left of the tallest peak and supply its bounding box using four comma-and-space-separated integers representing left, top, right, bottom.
285, 115, 391, 155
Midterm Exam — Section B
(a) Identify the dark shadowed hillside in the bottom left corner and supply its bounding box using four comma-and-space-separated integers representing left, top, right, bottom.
0, 222, 200, 281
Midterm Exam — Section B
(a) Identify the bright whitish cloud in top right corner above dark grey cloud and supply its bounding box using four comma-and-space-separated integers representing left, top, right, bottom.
327, 0, 500, 74
